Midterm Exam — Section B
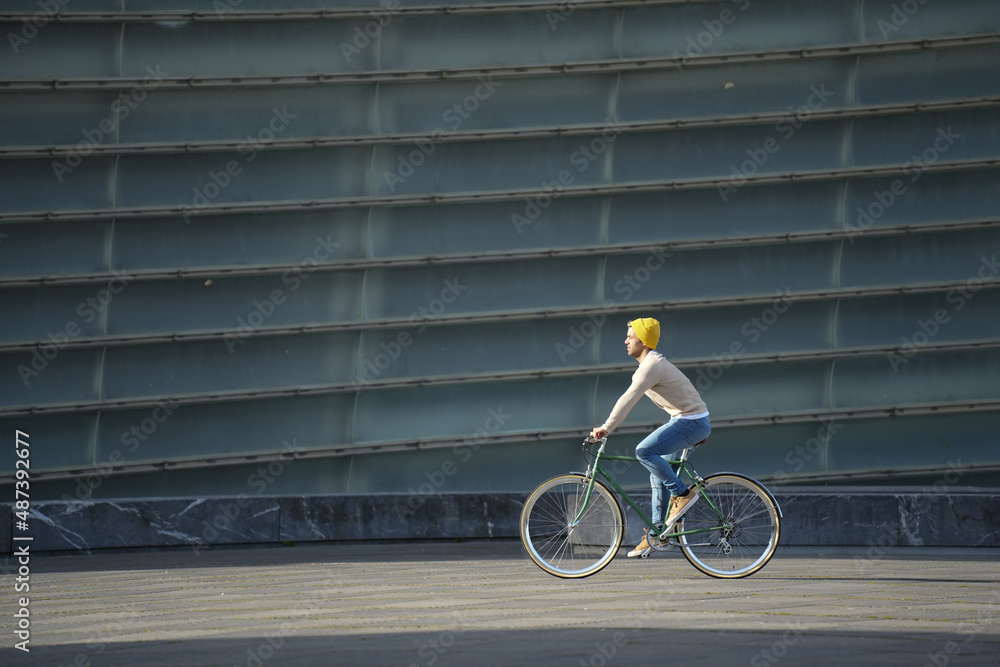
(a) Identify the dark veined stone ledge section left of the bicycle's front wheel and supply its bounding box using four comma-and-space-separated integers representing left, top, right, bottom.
0, 493, 524, 553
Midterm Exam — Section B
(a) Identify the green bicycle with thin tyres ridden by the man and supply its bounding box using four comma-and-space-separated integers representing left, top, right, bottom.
520, 437, 782, 579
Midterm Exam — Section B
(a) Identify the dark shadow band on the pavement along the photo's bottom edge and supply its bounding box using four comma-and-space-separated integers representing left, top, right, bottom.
0, 619, 1000, 667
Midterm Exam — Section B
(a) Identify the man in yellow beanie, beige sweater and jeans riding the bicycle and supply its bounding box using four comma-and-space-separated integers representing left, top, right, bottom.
590, 317, 712, 558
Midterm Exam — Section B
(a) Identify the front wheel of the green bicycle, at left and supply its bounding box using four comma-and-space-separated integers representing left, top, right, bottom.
521, 474, 625, 578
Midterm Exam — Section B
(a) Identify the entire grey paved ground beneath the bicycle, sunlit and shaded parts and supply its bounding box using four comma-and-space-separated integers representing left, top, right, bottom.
0, 540, 1000, 667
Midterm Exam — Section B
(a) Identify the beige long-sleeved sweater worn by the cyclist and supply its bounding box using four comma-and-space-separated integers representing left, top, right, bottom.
601, 350, 708, 433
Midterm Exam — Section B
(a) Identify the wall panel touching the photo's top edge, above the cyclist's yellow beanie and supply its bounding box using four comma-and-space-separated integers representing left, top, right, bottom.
622, 0, 856, 57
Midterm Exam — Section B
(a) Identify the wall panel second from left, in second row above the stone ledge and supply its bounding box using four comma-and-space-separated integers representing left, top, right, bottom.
96, 394, 354, 461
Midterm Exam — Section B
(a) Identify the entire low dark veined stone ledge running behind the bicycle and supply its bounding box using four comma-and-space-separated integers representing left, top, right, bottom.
0, 488, 1000, 553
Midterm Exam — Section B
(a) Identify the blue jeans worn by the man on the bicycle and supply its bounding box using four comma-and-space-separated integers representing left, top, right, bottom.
635, 417, 712, 523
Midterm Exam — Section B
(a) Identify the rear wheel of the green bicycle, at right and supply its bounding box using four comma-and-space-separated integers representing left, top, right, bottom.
678, 473, 781, 579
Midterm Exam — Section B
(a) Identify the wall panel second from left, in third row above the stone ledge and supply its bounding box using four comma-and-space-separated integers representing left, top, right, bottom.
101, 333, 359, 399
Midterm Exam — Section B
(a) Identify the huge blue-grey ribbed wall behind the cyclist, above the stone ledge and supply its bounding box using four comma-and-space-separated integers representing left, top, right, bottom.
0, 0, 1000, 498
